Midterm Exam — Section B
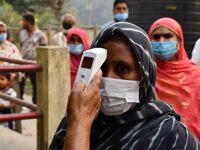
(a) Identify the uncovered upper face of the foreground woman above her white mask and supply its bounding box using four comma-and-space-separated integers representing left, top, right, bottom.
101, 37, 141, 80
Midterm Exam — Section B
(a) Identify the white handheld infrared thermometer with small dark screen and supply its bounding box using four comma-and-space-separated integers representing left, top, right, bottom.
75, 48, 107, 86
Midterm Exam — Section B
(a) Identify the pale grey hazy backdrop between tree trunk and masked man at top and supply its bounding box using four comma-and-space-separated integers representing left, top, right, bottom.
69, 0, 114, 25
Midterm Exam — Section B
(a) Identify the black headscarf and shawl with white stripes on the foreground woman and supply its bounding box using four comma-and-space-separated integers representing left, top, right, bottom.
49, 22, 200, 150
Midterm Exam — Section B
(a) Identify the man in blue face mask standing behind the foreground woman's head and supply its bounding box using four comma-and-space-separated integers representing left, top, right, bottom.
102, 0, 129, 29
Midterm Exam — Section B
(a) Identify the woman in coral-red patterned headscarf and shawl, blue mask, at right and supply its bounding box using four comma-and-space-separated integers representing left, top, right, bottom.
149, 18, 200, 140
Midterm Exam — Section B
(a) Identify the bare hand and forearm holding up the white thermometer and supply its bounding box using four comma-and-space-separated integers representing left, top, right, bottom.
63, 71, 102, 150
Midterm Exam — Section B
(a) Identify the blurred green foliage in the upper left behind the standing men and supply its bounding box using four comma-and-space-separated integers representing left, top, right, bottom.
0, 0, 77, 29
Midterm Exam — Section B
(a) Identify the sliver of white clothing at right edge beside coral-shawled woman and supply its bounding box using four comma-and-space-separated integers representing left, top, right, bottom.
191, 39, 200, 66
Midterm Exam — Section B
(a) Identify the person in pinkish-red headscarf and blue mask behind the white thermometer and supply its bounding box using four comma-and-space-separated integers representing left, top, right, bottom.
67, 28, 89, 87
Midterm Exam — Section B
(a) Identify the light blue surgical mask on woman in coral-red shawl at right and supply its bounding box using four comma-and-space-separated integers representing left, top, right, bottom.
151, 42, 177, 61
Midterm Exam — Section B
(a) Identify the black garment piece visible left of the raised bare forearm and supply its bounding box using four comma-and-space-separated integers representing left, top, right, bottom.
49, 117, 67, 150
